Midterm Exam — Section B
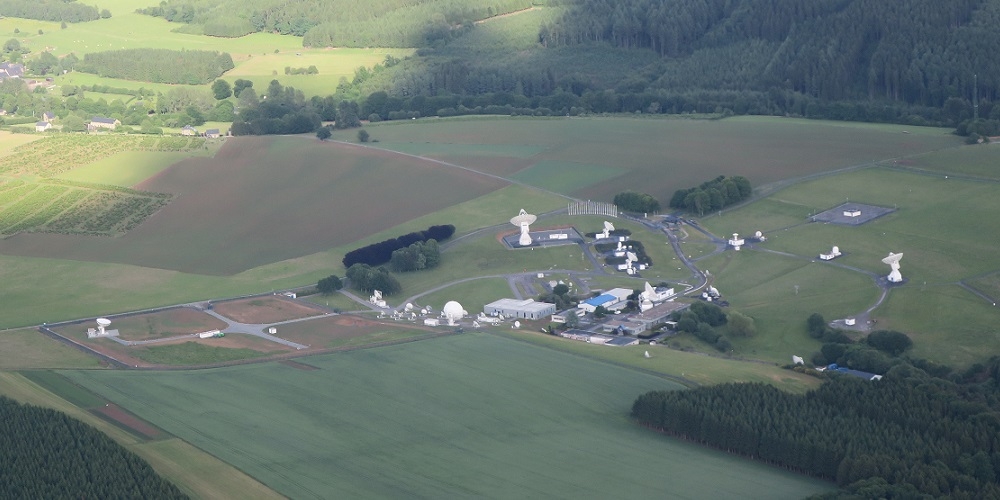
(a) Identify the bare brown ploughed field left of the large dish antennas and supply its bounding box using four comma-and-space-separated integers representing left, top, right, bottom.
0, 137, 506, 275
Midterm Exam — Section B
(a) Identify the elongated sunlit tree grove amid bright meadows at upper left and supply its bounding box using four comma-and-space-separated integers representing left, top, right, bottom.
76, 49, 235, 85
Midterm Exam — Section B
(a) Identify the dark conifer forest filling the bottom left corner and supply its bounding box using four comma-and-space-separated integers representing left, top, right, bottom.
0, 396, 187, 499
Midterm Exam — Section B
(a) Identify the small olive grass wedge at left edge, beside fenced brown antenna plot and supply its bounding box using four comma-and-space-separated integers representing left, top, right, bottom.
0, 328, 100, 370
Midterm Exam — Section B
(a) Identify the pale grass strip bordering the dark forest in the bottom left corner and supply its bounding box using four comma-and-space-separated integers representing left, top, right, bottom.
0, 372, 283, 498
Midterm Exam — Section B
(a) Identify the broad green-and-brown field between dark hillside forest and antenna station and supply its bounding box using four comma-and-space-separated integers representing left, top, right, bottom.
360, 117, 960, 205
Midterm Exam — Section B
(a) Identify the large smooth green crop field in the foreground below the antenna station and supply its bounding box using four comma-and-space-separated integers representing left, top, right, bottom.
58, 334, 832, 498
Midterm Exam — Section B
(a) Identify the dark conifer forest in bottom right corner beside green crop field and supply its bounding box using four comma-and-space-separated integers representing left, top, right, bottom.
632, 358, 1000, 499
